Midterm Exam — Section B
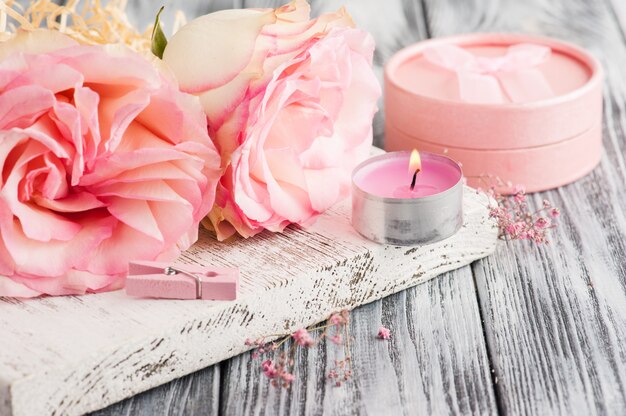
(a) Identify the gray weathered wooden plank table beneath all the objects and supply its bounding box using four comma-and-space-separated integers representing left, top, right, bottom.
91, 0, 626, 416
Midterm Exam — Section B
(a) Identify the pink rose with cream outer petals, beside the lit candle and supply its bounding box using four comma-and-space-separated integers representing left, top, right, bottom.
163, 0, 380, 239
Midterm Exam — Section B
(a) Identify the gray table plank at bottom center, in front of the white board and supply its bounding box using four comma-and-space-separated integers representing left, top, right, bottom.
218, 267, 496, 415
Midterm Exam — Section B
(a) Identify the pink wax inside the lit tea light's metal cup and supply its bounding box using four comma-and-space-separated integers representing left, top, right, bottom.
354, 152, 462, 199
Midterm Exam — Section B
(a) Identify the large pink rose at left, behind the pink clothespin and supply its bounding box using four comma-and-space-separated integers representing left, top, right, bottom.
0, 30, 220, 297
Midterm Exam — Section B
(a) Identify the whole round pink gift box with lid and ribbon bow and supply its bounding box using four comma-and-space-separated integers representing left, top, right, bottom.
385, 33, 602, 192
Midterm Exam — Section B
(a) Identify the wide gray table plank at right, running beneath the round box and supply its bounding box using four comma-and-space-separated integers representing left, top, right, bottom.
425, 0, 626, 415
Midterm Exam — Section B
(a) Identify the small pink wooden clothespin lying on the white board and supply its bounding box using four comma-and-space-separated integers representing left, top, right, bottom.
126, 261, 239, 300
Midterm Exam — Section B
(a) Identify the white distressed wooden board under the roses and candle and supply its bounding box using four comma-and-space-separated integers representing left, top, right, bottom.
0, 184, 497, 416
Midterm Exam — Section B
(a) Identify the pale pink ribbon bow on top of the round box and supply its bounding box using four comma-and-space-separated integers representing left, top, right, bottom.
424, 43, 554, 104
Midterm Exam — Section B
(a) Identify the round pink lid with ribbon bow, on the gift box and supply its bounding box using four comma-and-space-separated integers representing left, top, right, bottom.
385, 33, 602, 150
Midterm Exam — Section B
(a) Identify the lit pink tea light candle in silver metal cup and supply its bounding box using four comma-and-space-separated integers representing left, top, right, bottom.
352, 151, 463, 246
